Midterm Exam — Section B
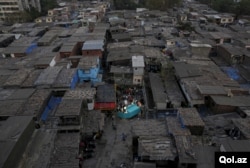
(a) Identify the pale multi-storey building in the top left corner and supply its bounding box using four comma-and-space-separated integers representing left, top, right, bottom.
0, 0, 41, 21
